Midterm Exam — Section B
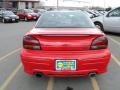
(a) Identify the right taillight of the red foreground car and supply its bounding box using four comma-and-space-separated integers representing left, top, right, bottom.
90, 36, 108, 50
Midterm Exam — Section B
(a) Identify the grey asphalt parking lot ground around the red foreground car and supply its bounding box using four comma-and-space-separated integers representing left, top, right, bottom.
0, 21, 120, 90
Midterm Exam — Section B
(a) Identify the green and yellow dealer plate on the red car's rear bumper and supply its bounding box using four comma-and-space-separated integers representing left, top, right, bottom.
56, 60, 76, 71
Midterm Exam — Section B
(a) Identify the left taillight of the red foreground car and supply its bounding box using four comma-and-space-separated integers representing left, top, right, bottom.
23, 35, 41, 50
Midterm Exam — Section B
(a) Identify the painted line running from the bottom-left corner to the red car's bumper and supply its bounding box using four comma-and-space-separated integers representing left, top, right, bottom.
0, 63, 22, 90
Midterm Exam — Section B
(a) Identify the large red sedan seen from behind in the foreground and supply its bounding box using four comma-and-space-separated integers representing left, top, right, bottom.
21, 11, 111, 77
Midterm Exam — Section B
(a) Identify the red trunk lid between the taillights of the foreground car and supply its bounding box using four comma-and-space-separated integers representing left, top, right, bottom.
29, 28, 102, 51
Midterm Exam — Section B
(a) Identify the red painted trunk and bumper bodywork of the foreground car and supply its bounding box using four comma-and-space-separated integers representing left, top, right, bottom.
21, 28, 111, 76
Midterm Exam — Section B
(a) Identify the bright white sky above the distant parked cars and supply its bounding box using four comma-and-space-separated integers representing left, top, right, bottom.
41, 0, 120, 7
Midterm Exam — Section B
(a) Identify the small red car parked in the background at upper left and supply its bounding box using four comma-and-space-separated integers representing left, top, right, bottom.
17, 9, 39, 21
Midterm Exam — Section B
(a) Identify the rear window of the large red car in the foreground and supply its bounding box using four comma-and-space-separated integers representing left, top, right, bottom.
35, 12, 94, 28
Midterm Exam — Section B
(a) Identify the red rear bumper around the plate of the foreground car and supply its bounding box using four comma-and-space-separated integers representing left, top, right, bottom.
21, 49, 111, 76
